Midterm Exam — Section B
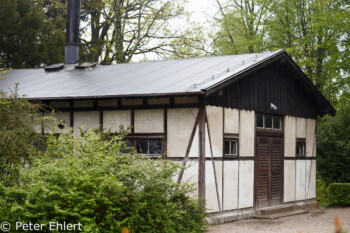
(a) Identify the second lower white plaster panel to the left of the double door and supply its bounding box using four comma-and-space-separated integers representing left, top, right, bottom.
223, 161, 238, 210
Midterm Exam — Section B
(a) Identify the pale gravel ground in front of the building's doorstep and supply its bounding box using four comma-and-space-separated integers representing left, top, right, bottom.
208, 208, 350, 233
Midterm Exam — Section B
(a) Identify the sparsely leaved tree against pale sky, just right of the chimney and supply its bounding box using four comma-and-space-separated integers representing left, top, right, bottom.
81, 0, 199, 64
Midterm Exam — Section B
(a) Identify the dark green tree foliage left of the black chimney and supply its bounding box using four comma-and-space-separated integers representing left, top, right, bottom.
0, 0, 65, 68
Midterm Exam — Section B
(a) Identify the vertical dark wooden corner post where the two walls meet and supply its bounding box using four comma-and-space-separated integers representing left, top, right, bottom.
198, 107, 205, 199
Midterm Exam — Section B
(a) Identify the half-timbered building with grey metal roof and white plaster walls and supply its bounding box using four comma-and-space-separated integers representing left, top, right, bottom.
0, 50, 335, 220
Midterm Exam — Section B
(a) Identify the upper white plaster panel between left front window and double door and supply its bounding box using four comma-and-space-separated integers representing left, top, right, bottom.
239, 110, 255, 156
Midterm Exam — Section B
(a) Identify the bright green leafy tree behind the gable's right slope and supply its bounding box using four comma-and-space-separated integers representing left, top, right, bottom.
266, 0, 348, 103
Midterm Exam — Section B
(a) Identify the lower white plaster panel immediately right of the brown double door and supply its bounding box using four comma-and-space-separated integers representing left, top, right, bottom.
283, 160, 295, 202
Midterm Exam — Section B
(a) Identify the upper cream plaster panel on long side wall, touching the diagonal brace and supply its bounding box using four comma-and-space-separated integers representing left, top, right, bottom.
167, 108, 198, 157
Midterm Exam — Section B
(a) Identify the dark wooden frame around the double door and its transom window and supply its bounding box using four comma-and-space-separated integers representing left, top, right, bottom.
253, 115, 285, 209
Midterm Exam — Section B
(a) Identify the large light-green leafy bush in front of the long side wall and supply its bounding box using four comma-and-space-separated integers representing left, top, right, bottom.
0, 131, 205, 232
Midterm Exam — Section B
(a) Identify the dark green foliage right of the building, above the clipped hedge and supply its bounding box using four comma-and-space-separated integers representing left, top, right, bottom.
317, 105, 350, 184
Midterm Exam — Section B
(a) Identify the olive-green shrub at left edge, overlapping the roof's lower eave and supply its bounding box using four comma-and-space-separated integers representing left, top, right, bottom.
0, 86, 42, 186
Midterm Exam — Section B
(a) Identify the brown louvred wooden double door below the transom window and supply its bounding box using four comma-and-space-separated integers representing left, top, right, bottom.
255, 132, 284, 209
